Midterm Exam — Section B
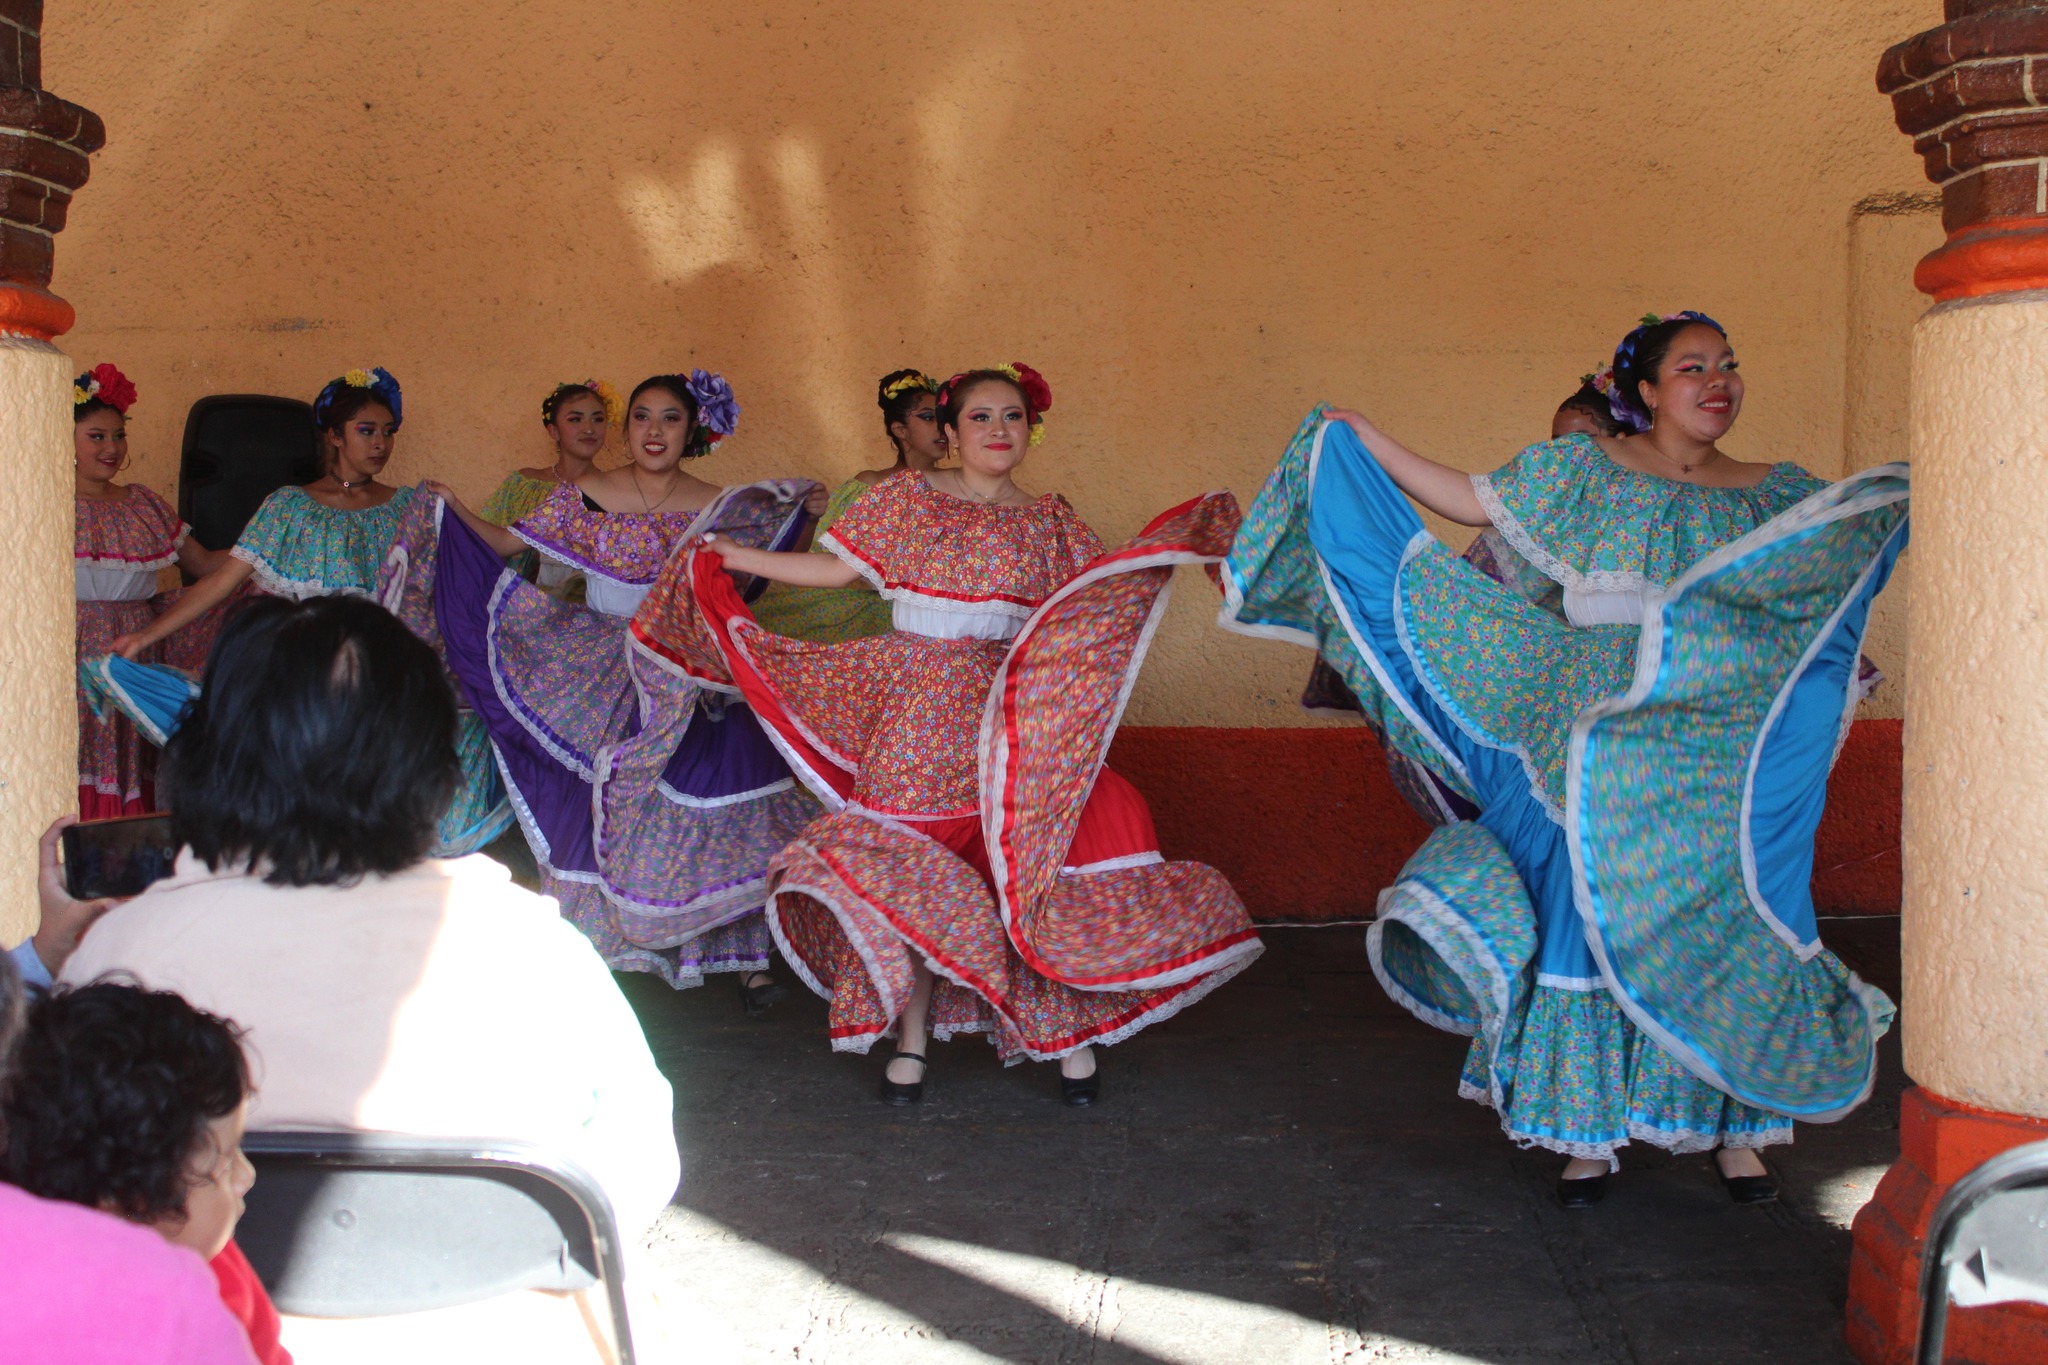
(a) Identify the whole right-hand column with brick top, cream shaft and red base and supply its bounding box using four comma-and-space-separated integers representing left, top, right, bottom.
1847, 0, 2048, 1365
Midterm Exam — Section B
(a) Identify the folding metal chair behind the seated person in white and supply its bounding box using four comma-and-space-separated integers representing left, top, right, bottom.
236, 1132, 633, 1365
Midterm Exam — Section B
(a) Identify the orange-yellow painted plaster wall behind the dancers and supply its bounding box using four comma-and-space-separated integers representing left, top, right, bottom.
43, 0, 1939, 724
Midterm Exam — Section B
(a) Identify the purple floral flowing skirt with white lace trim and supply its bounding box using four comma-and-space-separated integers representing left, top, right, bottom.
383, 489, 817, 988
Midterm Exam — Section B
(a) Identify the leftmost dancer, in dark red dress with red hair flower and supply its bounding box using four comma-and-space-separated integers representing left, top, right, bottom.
72, 364, 223, 821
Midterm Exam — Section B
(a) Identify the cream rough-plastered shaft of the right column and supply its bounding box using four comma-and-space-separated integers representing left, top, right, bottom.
1903, 291, 2048, 1117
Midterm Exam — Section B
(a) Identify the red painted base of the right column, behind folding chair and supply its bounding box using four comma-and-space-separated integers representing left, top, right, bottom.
1845, 1085, 2048, 1365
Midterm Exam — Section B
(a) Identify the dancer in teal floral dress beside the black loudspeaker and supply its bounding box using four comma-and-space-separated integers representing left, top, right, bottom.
102, 366, 512, 857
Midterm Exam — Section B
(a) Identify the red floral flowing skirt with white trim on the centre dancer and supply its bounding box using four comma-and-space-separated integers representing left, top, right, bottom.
633, 493, 1262, 1062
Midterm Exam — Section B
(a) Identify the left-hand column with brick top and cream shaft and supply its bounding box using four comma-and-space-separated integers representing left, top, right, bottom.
0, 0, 106, 943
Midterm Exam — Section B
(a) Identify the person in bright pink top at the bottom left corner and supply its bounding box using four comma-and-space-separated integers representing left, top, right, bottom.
0, 956, 256, 1365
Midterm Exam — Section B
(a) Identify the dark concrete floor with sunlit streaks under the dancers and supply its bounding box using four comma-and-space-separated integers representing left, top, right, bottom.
625, 921, 1903, 1365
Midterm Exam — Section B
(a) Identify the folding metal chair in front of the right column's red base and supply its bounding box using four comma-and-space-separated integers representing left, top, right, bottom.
1915, 1142, 2048, 1365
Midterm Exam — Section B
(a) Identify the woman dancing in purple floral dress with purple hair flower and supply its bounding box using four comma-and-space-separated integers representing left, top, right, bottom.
383, 370, 823, 1013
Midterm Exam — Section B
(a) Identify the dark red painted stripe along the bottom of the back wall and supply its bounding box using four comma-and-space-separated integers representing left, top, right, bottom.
1110, 720, 1903, 923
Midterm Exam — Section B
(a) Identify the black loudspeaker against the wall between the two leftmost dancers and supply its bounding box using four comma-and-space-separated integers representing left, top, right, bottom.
178, 393, 319, 551
